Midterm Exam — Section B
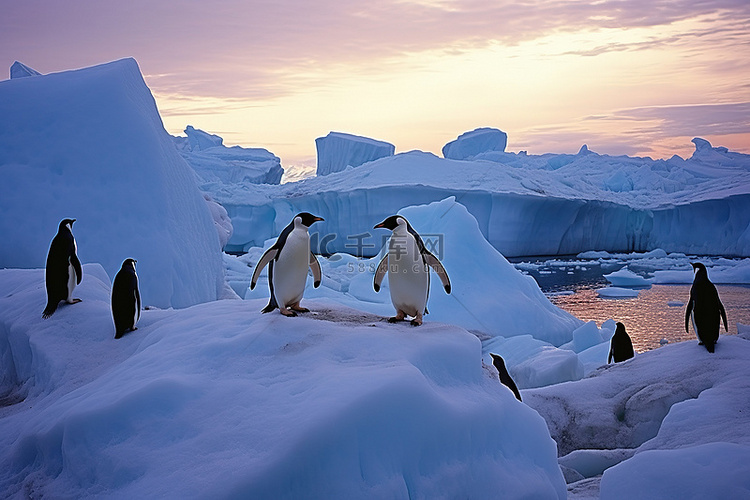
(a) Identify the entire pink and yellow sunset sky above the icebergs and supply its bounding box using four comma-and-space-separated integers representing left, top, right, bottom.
0, 0, 750, 172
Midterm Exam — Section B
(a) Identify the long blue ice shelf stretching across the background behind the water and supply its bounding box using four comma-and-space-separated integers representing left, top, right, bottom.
212, 141, 750, 257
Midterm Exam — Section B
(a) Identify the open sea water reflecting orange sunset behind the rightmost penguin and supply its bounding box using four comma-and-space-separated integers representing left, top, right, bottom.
516, 259, 750, 352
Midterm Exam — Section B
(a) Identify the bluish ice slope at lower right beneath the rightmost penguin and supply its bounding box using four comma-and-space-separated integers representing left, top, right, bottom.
522, 335, 750, 500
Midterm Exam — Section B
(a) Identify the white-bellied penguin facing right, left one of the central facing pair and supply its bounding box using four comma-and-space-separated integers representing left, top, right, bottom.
250, 212, 324, 316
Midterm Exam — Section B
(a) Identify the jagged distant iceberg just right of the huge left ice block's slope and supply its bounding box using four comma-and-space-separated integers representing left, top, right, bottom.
172, 125, 284, 188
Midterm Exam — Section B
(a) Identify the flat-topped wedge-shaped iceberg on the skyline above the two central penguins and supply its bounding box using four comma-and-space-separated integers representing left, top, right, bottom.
315, 132, 396, 175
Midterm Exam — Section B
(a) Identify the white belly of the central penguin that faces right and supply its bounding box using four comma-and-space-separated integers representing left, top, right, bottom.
273, 229, 310, 308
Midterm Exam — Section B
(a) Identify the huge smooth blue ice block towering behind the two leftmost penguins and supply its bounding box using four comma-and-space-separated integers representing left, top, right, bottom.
0, 59, 223, 308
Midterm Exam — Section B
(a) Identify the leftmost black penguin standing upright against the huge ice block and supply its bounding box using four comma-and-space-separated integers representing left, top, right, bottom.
42, 219, 83, 319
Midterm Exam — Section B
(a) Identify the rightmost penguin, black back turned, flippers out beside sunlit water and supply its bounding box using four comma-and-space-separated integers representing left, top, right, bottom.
685, 262, 729, 352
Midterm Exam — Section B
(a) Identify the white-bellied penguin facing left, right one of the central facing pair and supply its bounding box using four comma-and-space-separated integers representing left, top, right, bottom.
372, 215, 451, 326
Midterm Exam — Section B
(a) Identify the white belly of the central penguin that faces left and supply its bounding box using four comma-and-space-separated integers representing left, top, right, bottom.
388, 238, 429, 316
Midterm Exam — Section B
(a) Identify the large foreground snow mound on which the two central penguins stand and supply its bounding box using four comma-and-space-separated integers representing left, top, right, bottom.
0, 266, 566, 499
